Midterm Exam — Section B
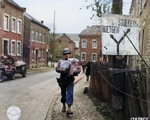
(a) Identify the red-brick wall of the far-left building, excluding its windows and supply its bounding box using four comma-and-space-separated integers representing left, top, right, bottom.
0, 3, 23, 59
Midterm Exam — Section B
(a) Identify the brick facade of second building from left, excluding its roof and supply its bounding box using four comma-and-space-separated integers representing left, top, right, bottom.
24, 16, 49, 68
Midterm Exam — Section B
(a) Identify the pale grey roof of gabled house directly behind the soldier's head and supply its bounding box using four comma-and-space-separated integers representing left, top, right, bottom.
56, 33, 80, 48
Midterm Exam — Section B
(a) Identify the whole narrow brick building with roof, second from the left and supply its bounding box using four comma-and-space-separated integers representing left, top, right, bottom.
23, 12, 50, 68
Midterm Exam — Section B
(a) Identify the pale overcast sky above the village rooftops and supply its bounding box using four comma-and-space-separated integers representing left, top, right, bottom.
14, 0, 131, 34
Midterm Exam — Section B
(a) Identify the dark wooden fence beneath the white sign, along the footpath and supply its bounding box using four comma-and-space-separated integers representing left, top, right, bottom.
90, 62, 149, 120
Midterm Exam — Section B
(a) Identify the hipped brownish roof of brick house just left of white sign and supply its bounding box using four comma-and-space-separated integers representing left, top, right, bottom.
79, 25, 101, 36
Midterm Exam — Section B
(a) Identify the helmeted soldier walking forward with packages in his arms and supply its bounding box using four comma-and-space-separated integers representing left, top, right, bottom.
56, 48, 80, 115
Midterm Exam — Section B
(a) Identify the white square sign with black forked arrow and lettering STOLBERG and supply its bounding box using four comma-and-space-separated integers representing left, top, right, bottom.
101, 14, 139, 55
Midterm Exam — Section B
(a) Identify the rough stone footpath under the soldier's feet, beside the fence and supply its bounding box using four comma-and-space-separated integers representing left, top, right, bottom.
45, 73, 104, 120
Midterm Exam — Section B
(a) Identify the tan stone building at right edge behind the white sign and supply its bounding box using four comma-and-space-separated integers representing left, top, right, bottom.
128, 0, 150, 68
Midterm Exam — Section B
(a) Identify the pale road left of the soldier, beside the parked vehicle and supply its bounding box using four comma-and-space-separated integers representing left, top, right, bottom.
0, 70, 59, 120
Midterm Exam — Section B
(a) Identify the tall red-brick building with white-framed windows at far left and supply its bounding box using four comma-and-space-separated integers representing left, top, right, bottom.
0, 0, 24, 60
